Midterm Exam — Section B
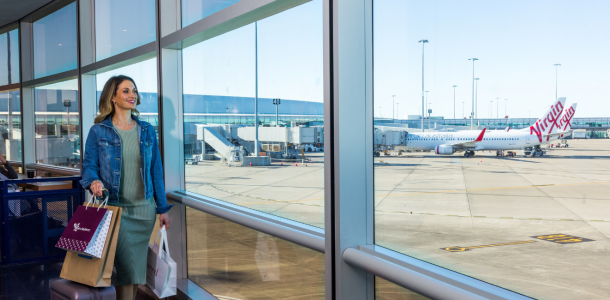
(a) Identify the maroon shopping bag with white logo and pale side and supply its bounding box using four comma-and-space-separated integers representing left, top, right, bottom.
55, 197, 112, 258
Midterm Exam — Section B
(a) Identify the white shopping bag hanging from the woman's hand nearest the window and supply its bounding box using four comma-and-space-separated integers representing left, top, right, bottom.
146, 225, 178, 298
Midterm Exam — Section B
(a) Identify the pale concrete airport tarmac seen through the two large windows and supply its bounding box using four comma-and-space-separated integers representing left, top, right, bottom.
186, 139, 610, 299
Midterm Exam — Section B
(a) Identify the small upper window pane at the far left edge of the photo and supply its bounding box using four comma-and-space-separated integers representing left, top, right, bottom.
0, 29, 19, 86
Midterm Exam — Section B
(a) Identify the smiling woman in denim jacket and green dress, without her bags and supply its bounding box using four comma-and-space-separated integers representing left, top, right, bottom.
81, 75, 171, 300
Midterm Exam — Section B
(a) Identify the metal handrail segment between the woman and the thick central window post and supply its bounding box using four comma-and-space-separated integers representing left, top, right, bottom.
162, 192, 325, 253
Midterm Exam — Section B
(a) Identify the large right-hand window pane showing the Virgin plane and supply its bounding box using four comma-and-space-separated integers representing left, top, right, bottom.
373, 0, 610, 299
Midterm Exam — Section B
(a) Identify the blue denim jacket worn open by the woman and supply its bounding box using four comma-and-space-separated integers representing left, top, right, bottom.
80, 116, 173, 214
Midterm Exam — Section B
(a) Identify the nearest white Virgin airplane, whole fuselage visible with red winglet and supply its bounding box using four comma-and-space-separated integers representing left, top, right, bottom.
406, 97, 571, 157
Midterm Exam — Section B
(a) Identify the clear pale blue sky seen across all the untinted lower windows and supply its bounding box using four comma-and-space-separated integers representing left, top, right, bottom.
29, 0, 610, 118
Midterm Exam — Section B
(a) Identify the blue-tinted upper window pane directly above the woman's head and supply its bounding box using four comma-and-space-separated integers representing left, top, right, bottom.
95, 0, 156, 60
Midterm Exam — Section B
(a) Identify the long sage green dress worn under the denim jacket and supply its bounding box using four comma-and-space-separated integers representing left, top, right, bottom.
114, 125, 156, 286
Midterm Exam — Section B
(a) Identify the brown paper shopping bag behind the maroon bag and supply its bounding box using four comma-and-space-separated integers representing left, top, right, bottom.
59, 204, 122, 287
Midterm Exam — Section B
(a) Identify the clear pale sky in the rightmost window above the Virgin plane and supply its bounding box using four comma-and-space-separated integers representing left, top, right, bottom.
374, 0, 610, 118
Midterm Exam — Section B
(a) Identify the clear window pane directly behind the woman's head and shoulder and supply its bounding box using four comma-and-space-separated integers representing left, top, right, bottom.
96, 58, 159, 133
